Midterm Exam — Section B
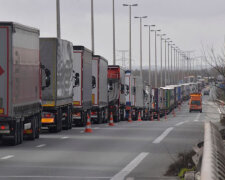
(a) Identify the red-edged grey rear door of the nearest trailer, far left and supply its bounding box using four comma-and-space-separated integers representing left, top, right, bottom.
0, 26, 9, 116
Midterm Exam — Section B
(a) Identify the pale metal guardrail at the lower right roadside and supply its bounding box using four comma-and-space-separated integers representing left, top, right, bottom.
201, 122, 225, 180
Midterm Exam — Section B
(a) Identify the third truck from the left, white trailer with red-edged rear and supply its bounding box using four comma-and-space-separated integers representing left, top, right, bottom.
73, 46, 94, 126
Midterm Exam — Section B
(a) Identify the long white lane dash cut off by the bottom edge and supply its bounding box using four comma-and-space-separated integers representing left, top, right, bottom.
111, 152, 149, 180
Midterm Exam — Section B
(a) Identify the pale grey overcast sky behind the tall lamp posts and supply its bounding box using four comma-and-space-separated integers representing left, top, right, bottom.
0, 0, 225, 69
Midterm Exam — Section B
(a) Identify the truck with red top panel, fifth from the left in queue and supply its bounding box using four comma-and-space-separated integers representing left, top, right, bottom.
108, 65, 126, 122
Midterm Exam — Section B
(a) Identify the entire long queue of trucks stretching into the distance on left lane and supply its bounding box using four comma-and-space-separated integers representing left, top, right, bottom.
0, 22, 208, 145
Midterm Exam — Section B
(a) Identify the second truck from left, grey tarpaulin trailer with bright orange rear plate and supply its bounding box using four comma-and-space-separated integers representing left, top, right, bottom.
40, 38, 74, 132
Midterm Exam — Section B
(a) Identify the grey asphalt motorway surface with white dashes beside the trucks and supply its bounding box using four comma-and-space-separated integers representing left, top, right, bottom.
0, 93, 219, 180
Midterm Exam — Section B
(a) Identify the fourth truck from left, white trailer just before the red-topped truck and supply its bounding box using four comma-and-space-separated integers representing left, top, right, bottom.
91, 55, 108, 124
